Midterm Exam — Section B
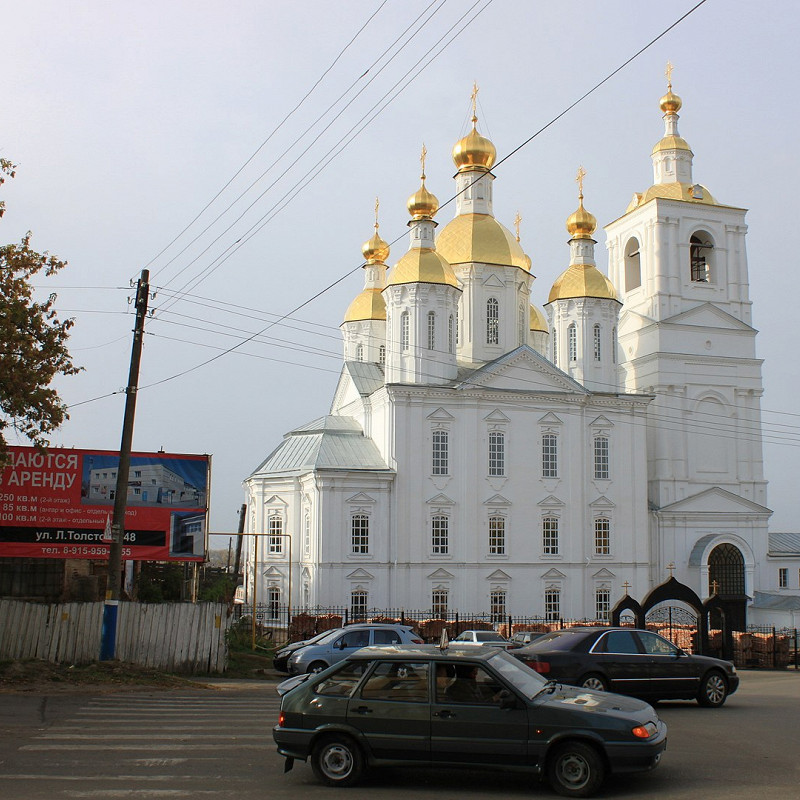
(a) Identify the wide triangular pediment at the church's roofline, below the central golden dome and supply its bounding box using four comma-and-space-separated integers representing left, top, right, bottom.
456, 345, 589, 395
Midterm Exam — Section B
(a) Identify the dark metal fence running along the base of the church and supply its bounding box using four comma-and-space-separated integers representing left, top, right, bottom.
235, 603, 800, 669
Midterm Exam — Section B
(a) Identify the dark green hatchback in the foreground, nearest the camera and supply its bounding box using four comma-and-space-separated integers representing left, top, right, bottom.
273, 645, 667, 797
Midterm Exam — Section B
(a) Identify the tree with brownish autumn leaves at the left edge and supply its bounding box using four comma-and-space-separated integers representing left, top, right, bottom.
0, 159, 81, 466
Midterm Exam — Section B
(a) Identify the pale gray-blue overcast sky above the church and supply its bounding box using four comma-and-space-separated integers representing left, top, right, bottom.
0, 0, 800, 546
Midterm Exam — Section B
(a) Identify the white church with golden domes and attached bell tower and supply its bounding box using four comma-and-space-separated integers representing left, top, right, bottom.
244, 76, 800, 622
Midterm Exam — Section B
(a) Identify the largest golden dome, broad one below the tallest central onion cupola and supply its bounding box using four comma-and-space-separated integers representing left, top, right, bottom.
436, 214, 531, 272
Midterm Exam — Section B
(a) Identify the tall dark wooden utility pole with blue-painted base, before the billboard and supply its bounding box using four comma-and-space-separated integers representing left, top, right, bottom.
100, 269, 150, 661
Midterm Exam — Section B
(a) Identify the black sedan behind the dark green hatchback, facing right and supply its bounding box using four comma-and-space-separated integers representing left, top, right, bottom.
511, 627, 739, 707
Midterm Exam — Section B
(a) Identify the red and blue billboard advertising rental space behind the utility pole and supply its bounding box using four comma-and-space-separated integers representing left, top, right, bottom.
0, 447, 210, 561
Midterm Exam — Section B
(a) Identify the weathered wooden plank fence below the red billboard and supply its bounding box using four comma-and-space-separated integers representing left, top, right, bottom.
0, 600, 231, 674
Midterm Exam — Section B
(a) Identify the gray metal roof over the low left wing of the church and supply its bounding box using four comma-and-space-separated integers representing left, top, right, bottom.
251, 415, 390, 477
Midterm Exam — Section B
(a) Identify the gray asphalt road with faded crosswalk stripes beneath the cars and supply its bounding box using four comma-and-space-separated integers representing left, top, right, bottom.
0, 672, 800, 800
